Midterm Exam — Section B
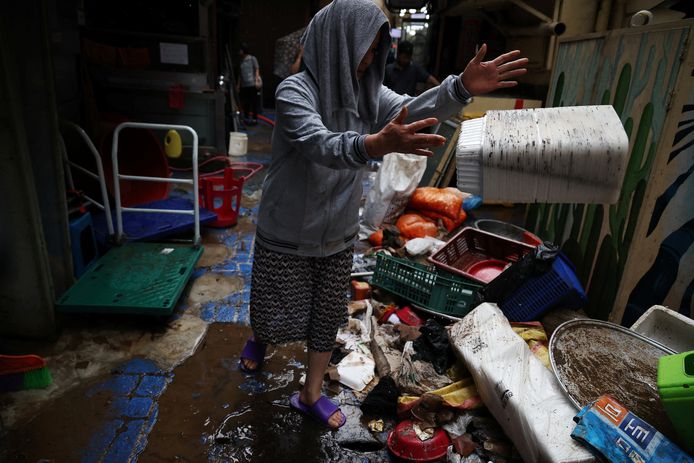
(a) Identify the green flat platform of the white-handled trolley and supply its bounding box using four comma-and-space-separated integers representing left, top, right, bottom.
56, 243, 203, 315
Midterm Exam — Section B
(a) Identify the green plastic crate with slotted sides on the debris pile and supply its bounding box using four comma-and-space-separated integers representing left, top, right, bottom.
371, 254, 482, 317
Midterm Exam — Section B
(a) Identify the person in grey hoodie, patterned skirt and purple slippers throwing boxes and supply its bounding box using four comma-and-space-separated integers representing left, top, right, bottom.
240, 0, 527, 429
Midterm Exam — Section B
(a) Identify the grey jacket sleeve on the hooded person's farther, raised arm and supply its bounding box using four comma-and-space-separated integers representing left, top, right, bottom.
375, 75, 472, 132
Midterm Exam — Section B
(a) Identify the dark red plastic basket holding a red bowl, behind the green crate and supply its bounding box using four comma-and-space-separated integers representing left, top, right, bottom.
428, 227, 533, 283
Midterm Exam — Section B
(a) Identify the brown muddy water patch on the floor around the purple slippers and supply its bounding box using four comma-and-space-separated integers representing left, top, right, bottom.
139, 324, 387, 463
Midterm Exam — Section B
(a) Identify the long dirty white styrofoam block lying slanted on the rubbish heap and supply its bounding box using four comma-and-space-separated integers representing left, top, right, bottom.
448, 303, 595, 463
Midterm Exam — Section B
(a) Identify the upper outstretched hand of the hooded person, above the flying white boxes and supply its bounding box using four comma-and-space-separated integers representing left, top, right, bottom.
460, 43, 528, 96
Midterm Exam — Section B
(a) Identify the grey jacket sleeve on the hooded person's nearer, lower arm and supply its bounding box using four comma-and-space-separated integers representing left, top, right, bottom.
273, 78, 370, 169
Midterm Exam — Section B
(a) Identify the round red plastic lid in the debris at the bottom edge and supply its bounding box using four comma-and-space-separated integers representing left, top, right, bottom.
388, 420, 451, 462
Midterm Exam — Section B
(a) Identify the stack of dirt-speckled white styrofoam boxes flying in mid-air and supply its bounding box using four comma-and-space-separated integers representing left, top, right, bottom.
456, 105, 629, 204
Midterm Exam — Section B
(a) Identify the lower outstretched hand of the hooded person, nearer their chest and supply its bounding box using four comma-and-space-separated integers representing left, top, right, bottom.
364, 106, 446, 158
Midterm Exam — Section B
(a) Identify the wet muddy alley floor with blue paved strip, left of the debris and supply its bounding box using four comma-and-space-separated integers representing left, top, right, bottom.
0, 120, 390, 463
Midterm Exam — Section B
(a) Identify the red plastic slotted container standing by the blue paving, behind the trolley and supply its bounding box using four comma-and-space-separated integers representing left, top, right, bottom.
199, 167, 246, 228
